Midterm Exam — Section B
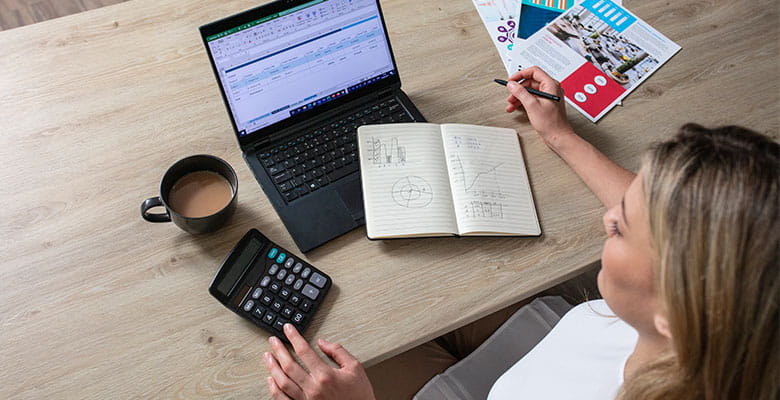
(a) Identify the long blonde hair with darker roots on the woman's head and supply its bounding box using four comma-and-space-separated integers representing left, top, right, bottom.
618, 124, 780, 400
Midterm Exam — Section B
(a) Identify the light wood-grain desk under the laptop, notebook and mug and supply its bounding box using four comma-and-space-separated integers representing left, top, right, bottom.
0, 0, 780, 398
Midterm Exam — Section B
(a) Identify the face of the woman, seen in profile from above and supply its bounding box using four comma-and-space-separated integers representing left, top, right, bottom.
598, 174, 658, 332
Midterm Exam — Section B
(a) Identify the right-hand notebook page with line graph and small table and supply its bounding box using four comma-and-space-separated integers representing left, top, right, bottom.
442, 124, 541, 235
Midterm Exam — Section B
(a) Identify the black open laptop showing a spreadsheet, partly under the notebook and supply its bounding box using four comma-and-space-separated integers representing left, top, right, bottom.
200, 0, 425, 252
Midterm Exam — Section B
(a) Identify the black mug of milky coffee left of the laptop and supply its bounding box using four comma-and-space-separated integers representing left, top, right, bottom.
141, 154, 238, 234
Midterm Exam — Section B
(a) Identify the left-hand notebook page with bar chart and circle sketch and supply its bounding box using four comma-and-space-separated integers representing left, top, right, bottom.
358, 123, 457, 238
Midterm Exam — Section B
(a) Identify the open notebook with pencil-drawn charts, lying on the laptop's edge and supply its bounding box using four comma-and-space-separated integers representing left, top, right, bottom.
358, 123, 541, 239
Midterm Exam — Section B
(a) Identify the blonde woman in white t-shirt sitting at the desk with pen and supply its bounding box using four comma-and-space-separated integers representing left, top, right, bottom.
258, 67, 780, 400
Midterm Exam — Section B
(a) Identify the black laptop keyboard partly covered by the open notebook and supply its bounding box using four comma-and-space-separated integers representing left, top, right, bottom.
258, 98, 414, 203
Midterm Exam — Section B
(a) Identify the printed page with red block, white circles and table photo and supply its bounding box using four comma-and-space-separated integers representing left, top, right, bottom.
512, 0, 680, 122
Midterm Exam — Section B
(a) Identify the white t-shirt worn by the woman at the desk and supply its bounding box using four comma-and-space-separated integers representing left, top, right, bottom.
488, 300, 637, 400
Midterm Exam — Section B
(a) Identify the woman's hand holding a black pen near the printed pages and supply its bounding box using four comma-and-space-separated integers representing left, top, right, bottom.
506, 66, 574, 144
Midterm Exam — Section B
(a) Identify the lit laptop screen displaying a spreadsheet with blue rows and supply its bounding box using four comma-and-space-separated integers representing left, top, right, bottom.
205, 0, 396, 136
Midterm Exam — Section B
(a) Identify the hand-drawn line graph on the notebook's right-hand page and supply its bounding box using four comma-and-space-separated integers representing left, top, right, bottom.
450, 153, 506, 199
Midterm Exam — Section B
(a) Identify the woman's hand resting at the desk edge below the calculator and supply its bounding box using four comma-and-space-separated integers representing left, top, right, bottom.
263, 324, 374, 400
